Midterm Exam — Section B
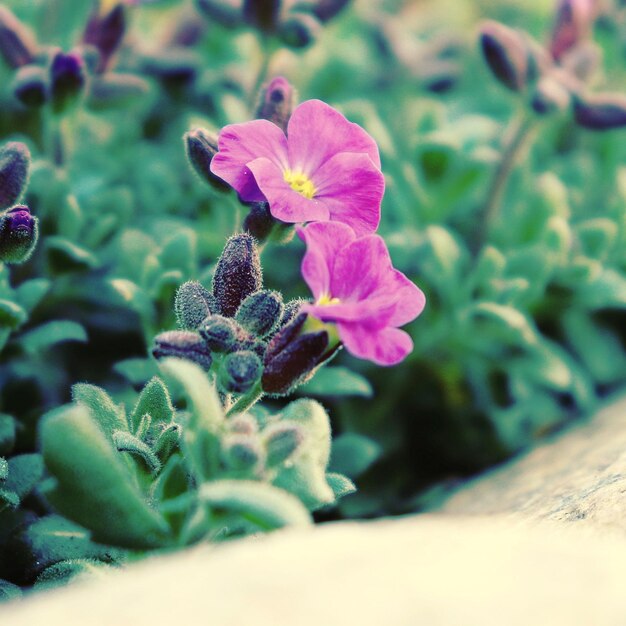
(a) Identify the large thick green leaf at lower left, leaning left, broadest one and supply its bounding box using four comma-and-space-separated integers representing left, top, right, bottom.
41, 405, 169, 549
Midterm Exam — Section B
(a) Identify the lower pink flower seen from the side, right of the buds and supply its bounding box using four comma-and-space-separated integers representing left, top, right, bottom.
298, 222, 426, 365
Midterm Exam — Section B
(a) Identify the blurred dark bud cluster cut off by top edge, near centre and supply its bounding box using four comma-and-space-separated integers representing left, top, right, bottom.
197, 0, 350, 48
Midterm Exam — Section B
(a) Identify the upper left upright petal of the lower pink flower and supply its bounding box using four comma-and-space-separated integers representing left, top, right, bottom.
296, 222, 356, 298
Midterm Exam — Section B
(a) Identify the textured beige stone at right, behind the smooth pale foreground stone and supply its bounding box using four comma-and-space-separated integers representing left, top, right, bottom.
440, 390, 626, 532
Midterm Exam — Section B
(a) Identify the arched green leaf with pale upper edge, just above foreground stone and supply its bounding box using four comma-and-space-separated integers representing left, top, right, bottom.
198, 480, 311, 530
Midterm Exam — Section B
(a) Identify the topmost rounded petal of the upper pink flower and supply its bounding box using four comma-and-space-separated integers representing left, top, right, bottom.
287, 100, 380, 176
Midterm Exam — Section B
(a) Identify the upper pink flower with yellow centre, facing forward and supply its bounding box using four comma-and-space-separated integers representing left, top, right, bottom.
211, 100, 385, 235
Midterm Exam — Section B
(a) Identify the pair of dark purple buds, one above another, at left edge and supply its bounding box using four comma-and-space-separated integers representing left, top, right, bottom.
0, 141, 38, 263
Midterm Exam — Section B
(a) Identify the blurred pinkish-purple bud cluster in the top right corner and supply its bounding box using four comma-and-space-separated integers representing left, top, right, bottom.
480, 0, 626, 130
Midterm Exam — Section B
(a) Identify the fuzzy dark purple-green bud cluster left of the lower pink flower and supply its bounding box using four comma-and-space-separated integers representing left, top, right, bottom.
152, 233, 332, 395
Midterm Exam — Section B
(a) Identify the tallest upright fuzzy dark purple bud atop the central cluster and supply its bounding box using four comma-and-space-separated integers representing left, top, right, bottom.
213, 233, 263, 317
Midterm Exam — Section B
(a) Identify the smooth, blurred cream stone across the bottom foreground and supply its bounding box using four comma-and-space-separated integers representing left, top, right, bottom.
0, 514, 626, 626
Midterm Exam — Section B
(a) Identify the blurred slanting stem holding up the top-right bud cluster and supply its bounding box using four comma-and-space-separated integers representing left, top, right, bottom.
475, 113, 536, 250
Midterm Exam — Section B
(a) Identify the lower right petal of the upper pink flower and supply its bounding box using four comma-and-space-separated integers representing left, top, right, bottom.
312, 152, 385, 236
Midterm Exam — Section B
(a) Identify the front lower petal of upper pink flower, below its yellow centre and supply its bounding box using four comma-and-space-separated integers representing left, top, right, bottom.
248, 158, 328, 224
